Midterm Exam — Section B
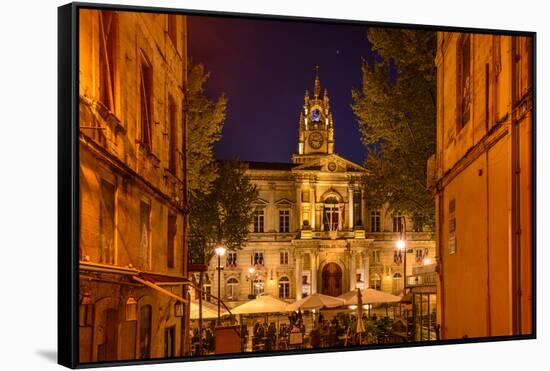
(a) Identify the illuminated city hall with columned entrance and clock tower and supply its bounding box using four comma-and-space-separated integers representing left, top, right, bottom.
204, 72, 435, 307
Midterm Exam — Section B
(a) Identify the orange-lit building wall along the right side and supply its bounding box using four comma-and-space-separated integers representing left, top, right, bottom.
428, 32, 533, 339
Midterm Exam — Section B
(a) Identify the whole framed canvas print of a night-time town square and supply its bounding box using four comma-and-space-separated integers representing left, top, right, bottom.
58, 3, 536, 368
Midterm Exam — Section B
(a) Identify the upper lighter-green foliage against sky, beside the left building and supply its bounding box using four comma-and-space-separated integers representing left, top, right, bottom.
186, 62, 227, 195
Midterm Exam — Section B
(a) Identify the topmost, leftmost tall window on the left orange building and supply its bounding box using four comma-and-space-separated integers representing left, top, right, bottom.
99, 10, 118, 112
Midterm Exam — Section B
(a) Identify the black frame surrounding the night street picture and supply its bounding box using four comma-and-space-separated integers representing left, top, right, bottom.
57, 2, 537, 368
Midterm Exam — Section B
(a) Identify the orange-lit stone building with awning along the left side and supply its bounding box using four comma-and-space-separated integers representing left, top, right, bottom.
79, 9, 187, 362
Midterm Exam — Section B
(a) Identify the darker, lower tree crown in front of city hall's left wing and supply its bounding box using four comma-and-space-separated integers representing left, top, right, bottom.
189, 161, 258, 262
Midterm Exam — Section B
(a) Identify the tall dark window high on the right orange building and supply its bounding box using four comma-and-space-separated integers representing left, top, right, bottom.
457, 34, 472, 130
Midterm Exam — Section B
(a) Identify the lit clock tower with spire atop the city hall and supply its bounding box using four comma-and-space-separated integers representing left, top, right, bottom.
293, 66, 334, 163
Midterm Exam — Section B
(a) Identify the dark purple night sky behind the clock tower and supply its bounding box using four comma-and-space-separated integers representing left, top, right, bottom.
188, 16, 374, 163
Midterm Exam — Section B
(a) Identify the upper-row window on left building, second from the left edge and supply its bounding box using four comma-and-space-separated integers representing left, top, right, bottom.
139, 52, 153, 151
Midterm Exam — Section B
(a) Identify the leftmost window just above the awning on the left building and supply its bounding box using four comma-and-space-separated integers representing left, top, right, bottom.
99, 179, 115, 264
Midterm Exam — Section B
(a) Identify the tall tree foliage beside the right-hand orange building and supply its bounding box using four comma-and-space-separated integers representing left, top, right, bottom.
352, 28, 436, 228
